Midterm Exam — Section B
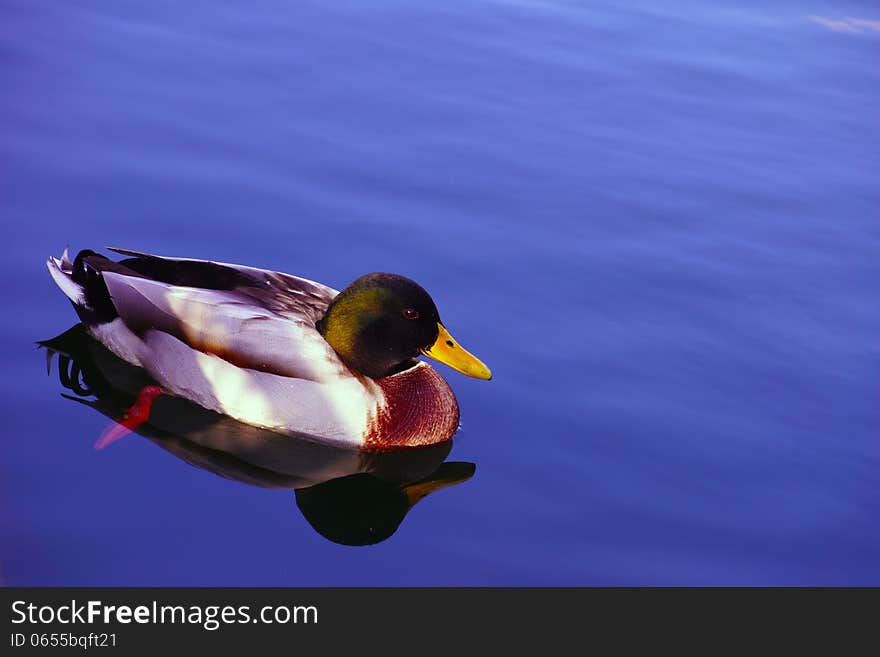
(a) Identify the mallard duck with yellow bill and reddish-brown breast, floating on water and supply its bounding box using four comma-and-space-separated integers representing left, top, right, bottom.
47, 248, 492, 450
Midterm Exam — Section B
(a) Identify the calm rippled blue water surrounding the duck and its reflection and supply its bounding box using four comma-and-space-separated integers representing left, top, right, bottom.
0, 0, 880, 585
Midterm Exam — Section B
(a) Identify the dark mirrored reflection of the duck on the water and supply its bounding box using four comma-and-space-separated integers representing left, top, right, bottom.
39, 324, 475, 545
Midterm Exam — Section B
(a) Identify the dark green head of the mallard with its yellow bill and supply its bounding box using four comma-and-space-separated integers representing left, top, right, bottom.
317, 273, 492, 380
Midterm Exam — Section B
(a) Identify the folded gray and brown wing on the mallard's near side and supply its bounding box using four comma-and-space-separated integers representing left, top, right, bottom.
96, 249, 348, 381
